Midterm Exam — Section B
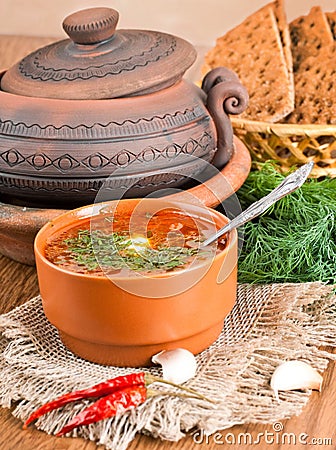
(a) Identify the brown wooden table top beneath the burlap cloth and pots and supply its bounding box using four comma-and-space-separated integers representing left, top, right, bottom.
0, 35, 336, 450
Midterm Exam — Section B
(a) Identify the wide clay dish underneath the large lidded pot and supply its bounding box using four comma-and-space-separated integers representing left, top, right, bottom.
0, 137, 251, 265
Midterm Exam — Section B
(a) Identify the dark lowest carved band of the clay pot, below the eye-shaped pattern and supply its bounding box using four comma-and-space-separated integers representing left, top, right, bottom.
0, 153, 207, 207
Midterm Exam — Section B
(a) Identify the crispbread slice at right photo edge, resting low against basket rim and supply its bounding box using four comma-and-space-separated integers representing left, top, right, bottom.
287, 43, 336, 125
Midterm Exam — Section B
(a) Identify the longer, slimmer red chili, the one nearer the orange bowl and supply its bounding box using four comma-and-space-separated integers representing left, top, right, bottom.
23, 372, 146, 429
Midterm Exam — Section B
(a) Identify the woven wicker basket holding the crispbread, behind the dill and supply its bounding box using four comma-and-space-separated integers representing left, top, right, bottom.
231, 117, 336, 178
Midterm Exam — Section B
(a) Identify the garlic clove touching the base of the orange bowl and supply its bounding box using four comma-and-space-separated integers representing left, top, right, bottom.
152, 348, 197, 384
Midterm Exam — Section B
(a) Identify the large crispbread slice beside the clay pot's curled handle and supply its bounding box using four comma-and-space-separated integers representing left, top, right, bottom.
205, 5, 294, 122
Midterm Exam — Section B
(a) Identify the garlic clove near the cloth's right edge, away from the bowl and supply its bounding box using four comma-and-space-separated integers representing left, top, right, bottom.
271, 361, 323, 401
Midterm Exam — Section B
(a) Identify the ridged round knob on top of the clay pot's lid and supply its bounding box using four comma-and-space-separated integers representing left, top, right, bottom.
63, 8, 119, 45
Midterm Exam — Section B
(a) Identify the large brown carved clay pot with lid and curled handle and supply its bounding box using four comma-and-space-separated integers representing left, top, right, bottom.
0, 8, 248, 208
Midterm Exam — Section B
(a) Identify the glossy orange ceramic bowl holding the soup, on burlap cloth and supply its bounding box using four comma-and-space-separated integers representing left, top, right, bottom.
35, 199, 237, 366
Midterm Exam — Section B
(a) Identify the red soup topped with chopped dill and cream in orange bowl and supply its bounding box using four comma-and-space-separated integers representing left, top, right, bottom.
45, 208, 226, 275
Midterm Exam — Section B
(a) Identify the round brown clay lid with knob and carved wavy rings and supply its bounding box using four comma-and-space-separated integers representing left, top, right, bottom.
1, 7, 196, 100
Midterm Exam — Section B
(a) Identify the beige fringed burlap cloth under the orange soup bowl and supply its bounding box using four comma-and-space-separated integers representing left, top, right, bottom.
0, 282, 336, 450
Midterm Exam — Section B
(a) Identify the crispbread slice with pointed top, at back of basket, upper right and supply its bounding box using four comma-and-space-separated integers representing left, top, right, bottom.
289, 6, 334, 71
